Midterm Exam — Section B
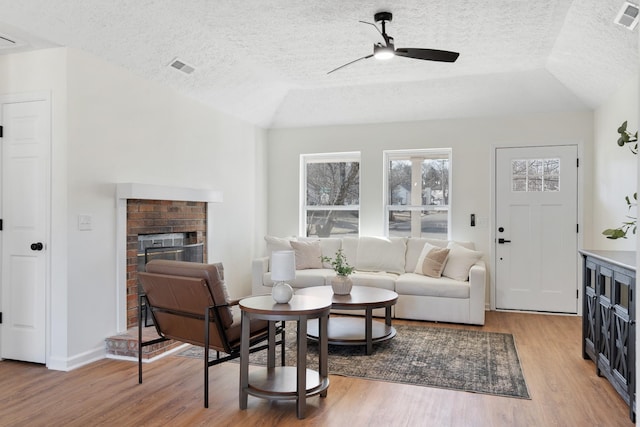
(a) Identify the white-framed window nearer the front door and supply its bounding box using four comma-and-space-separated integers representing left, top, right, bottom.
384, 149, 451, 239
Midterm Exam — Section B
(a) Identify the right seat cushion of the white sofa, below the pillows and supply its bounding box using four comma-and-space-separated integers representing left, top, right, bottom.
396, 273, 470, 298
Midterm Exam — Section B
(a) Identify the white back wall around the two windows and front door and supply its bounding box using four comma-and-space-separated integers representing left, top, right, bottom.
263, 112, 593, 302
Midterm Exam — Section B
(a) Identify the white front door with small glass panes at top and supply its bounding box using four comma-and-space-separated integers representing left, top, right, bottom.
495, 146, 578, 313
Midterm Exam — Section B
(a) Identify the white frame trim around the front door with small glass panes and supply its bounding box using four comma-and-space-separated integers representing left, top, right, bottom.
489, 144, 587, 316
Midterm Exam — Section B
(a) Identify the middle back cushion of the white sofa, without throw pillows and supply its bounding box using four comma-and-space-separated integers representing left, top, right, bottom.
355, 236, 407, 274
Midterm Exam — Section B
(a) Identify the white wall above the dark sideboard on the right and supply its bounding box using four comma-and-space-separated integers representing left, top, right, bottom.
590, 76, 639, 251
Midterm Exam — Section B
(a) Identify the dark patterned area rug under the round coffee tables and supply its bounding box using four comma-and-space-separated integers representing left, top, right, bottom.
177, 323, 530, 399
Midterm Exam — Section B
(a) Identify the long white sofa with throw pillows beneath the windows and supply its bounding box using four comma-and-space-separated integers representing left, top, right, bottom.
252, 236, 486, 325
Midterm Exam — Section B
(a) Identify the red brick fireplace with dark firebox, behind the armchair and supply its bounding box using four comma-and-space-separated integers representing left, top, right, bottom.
126, 199, 207, 328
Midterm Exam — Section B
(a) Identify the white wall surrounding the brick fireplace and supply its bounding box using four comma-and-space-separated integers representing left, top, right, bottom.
0, 49, 266, 369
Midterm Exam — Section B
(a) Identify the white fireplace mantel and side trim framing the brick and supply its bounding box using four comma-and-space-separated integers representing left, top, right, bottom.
116, 182, 222, 333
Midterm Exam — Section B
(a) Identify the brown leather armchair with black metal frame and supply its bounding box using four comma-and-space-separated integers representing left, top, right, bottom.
138, 259, 284, 408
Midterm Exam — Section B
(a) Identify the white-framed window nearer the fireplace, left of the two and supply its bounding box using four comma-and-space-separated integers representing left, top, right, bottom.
300, 153, 360, 237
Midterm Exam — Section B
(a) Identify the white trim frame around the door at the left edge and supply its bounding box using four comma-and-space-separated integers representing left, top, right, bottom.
0, 91, 53, 367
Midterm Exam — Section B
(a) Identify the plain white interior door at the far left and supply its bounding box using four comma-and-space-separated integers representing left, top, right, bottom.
0, 97, 51, 363
